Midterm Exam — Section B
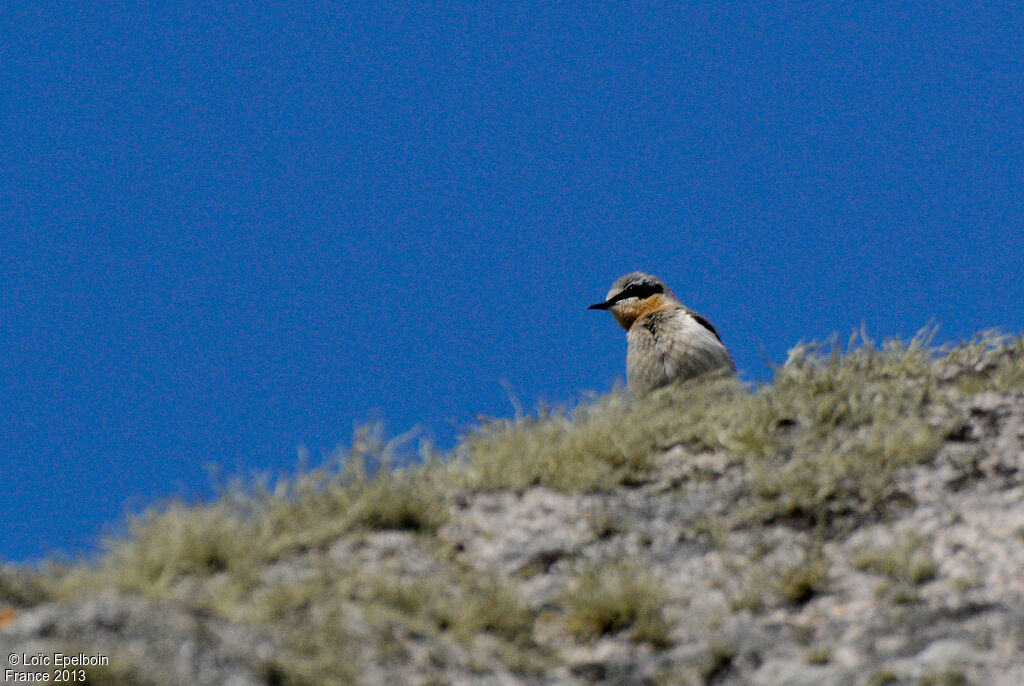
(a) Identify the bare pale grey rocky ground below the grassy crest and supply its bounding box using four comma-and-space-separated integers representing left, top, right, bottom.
0, 392, 1024, 686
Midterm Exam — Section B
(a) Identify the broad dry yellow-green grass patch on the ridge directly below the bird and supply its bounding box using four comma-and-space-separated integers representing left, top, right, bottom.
457, 331, 1024, 527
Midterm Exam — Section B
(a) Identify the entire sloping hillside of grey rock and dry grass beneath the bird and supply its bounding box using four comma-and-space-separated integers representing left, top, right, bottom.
0, 335, 1024, 686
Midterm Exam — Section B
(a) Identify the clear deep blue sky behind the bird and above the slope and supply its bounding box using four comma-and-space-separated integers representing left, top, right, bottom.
0, 1, 1024, 561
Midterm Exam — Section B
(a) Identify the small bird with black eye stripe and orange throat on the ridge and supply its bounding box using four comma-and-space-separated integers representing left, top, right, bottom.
587, 271, 736, 393
